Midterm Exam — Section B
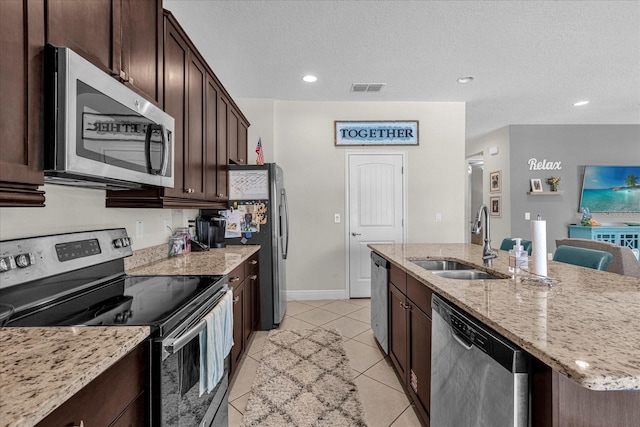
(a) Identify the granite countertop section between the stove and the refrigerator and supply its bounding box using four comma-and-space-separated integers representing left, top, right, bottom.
127, 245, 260, 276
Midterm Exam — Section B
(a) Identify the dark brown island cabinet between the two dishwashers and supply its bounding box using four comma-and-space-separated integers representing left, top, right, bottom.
389, 264, 433, 425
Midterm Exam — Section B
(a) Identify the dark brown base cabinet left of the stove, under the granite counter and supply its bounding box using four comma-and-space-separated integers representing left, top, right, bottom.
37, 343, 148, 427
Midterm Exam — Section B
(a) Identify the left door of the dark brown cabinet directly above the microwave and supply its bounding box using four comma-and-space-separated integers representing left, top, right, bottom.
45, 0, 117, 76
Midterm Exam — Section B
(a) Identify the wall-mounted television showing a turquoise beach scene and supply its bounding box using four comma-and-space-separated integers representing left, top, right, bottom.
580, 165, 640, 212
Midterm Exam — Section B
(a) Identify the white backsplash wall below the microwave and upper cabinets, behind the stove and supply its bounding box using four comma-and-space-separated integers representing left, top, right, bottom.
0, 185, 198, 250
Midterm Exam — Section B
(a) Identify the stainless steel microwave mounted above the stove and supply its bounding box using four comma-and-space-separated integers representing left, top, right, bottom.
43, 45, 175, 190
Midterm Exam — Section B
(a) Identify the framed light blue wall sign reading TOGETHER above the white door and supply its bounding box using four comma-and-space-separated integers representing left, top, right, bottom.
334, 120, 418, 146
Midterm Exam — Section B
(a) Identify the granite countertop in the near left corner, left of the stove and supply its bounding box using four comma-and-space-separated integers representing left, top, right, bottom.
0, 326, 150, 427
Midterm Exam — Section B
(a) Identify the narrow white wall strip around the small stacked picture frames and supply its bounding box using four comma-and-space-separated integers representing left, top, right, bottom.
466, 127, 510, 248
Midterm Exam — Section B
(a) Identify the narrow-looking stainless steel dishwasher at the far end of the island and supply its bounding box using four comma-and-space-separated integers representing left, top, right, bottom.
371, 252, 389, 354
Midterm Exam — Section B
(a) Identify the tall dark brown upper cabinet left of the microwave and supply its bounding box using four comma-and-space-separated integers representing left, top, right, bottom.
0, 0, 45, 207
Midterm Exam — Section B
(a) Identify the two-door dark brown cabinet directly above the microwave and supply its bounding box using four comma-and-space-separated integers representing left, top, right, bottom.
46, 0, 163, 105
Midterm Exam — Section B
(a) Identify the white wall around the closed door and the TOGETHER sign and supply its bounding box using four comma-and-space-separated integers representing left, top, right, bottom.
237, 99, 466, 292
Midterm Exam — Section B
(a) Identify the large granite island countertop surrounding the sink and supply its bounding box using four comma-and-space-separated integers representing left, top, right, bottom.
369, 244, 640, 390
